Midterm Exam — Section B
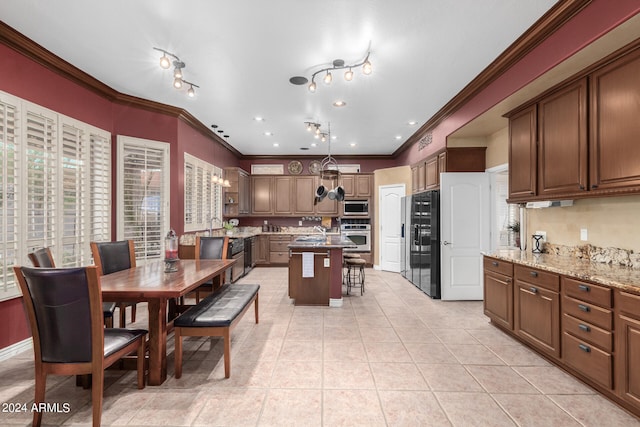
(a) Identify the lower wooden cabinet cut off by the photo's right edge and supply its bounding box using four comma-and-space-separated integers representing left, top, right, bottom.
614, 291, 640, 414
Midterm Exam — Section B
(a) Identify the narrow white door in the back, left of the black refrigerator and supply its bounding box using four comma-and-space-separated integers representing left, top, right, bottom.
378, 184, 405, 273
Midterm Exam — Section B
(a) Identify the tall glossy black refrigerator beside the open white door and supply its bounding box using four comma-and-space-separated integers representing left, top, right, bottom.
401, 190, 440, 299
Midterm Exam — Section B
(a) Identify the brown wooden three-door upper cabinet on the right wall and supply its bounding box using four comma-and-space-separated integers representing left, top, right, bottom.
507, 43, 640, 203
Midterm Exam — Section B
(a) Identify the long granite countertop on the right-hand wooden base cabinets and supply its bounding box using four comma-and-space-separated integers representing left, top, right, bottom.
483, 249, 640, 293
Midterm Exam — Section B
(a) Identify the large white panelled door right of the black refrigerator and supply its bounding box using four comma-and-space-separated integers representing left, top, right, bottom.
440, 172, 491, 300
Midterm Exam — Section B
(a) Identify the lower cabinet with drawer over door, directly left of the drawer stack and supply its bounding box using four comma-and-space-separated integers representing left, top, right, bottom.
513, 265, 560, 359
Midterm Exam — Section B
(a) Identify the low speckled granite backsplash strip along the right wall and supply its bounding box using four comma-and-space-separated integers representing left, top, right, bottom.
543, 242, 640, 270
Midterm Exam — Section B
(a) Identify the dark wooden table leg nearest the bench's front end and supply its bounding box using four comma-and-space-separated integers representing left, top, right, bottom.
148, 299, 167, 385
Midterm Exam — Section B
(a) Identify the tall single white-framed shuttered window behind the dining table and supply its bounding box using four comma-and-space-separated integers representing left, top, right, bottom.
117, 135, 170, 262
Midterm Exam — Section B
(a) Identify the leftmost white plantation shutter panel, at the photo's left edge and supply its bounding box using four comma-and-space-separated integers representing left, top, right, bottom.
0, 96, 20, 300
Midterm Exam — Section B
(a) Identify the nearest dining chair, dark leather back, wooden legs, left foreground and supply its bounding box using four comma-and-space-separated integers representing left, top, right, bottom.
13, 266, 147, 426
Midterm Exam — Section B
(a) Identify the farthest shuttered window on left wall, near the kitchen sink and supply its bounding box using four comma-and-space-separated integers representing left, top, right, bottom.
184, 153, 222, 231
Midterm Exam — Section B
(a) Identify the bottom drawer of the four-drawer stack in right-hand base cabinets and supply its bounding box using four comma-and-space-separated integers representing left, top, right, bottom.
562, 333, 613, 390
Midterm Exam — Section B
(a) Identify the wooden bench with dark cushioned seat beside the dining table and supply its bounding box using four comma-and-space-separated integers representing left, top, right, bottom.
173, 284, 260, 378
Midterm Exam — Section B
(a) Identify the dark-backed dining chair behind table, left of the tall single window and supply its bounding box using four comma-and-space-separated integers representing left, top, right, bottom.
90, 240, 136, 328
